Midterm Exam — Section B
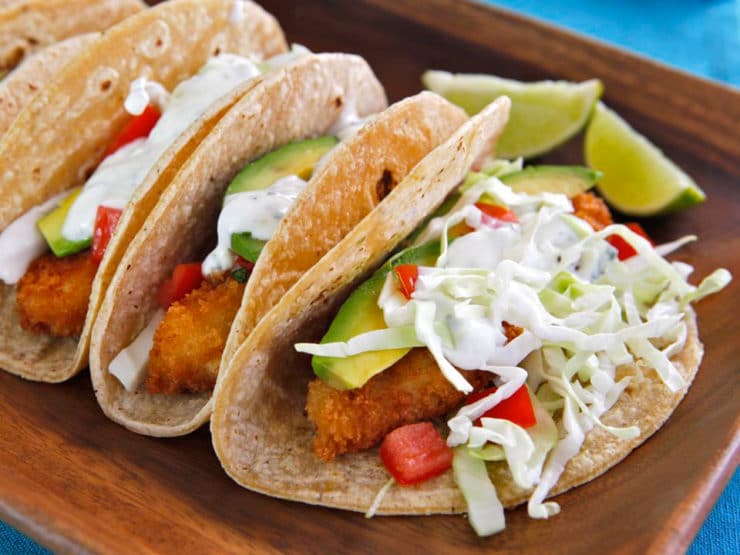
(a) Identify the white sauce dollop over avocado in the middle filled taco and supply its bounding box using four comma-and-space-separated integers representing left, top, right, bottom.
203, 175, 306, 276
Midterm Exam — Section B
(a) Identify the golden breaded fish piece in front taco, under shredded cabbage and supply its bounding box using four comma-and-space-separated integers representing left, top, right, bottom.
306, 349, 492, 461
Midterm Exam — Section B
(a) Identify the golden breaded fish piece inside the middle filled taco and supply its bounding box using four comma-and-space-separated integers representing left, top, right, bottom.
146, 278, 245, 394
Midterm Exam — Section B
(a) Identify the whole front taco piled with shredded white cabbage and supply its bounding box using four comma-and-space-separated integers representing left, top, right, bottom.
211, 97, 730, 535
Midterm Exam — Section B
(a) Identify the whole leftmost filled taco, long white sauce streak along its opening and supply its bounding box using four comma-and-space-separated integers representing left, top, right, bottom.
0, 0, 288, 382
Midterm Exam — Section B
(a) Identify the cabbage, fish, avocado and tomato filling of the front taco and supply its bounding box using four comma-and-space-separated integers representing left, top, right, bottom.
296, 162, 730, 535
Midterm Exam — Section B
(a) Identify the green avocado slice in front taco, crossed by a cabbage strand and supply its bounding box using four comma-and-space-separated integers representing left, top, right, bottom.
311, 241, 439, 389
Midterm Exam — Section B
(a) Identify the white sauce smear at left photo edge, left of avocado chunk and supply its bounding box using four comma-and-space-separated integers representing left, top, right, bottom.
0, 191, 69, 285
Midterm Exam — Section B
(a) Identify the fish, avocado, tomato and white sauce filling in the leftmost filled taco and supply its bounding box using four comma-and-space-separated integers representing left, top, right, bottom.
0, 47, 306, 337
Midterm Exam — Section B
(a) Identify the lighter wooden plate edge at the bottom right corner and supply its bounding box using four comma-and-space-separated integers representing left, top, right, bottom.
648, 416, 740, 553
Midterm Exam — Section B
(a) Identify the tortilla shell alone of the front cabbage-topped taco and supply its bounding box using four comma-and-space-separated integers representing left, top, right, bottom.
211, 96, 703, 514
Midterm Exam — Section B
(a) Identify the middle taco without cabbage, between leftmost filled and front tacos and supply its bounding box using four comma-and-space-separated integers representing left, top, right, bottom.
90, 58, 480, 436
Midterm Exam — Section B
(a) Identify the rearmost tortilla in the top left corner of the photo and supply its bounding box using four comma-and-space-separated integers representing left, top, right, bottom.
0, 0, 146, 71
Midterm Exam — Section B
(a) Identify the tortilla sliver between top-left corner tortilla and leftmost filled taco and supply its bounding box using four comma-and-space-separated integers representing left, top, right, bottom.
0, 33, 100, 136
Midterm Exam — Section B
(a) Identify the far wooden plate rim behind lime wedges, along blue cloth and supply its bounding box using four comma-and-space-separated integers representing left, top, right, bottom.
363, 0, 740, 173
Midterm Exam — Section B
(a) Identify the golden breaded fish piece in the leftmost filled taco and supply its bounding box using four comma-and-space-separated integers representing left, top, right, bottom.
17, 251, 98, 337
